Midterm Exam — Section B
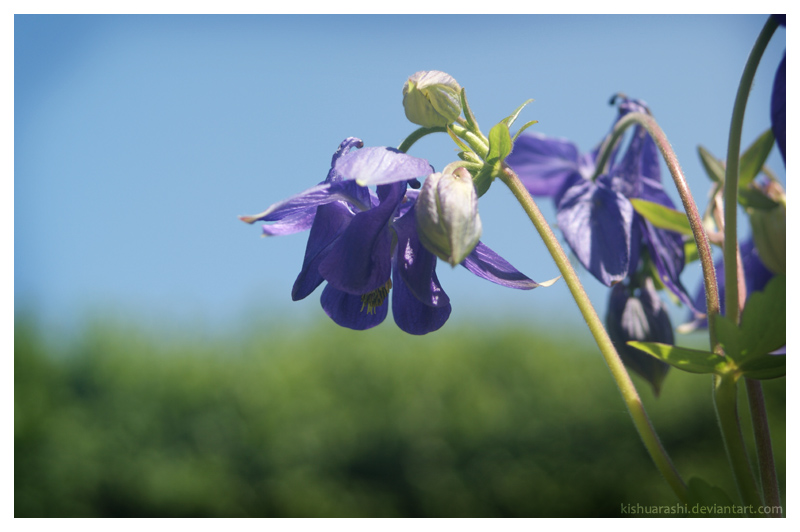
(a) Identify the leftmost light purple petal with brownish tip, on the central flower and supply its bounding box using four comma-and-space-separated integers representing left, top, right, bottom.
239, 183, 369, 223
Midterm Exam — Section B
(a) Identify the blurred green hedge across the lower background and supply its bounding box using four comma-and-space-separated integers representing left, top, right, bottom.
14, 317, 786, 517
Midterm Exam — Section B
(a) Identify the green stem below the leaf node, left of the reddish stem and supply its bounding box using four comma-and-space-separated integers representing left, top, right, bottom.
714, 375, 764, 515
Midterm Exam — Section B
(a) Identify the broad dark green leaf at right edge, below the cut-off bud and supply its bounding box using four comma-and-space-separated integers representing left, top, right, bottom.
726, 275, 786, 362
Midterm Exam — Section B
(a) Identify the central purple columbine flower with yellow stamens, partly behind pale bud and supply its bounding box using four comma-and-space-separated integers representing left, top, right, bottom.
240, 137, 539, 334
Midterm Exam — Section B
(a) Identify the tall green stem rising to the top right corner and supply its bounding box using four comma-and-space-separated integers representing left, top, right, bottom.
724, 17, 778, 324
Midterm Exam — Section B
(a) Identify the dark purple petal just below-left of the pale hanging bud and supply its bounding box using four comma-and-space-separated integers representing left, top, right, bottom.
392, 206, 450, 307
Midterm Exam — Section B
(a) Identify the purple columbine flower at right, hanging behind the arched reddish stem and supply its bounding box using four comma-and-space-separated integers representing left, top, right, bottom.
506, 97, 692, 307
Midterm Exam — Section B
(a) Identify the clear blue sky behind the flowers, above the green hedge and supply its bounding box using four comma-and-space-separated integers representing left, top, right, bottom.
14, 15, 786, 334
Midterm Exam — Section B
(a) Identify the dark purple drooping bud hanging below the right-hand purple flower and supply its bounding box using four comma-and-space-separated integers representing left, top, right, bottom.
606, 277, 675, 395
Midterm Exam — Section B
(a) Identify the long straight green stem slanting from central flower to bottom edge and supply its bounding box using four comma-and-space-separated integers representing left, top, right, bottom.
500, 166, 687, 503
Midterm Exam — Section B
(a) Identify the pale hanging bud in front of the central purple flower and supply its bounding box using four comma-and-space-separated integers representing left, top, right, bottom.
416, 163, 482, 266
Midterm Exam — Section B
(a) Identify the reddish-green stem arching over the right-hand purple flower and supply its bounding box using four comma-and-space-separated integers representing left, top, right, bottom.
598, 113, 722, 354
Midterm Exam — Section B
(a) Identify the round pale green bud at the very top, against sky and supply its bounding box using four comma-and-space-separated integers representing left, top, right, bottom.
403, 70, 461, 127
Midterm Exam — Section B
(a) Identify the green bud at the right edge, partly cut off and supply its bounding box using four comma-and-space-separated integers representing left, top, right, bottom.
748, 182, 786, 274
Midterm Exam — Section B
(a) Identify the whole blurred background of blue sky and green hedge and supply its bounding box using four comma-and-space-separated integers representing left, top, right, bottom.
14, 15, 785, 516
